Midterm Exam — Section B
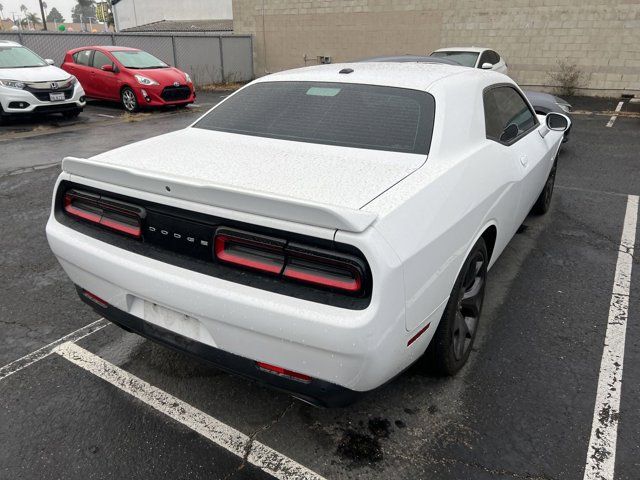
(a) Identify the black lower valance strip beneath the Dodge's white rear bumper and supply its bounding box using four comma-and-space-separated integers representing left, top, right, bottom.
76, 285, 362, 408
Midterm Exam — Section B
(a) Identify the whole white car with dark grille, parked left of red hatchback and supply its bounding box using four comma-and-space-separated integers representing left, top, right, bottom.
0, 40, 85, 122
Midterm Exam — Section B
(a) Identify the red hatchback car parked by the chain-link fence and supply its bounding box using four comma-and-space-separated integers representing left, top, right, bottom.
62, 46, 196, 112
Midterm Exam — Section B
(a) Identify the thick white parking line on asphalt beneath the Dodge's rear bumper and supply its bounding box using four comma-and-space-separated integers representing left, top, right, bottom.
55, 342, 324, 480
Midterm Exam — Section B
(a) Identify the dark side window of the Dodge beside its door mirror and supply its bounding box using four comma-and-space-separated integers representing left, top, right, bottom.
483, 86, 538, 145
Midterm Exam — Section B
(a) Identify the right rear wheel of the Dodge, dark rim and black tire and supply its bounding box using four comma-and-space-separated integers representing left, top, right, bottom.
424, 238, 489, 376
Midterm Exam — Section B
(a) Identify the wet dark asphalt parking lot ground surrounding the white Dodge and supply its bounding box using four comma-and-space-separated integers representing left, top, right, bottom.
0, 94, 640, 480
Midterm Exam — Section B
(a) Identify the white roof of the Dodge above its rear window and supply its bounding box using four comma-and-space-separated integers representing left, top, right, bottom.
256, 62, 484, 90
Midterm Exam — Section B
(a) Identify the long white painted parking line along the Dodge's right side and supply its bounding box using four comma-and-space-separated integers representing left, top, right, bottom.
584, 195, 639, 480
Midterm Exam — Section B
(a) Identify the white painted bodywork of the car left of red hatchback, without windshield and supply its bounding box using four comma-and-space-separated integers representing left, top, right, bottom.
0, 40, 86, 114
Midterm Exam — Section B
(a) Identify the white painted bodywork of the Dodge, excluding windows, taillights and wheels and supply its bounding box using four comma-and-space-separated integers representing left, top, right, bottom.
46, 63, 562, 404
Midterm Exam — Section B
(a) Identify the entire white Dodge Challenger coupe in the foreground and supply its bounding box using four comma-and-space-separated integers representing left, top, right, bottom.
47, 63, 569, 406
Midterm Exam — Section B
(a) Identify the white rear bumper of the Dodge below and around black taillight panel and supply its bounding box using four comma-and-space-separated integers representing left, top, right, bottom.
46, 173, 444, 404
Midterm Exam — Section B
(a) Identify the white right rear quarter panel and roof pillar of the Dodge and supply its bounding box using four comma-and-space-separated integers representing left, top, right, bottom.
364, 70, 519, 331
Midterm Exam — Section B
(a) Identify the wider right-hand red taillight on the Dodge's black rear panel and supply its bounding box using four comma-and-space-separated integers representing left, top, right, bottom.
214, 227, 365, 294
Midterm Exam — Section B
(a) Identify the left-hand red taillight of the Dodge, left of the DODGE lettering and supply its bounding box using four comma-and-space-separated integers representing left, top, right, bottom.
63, 190, 145, 238
